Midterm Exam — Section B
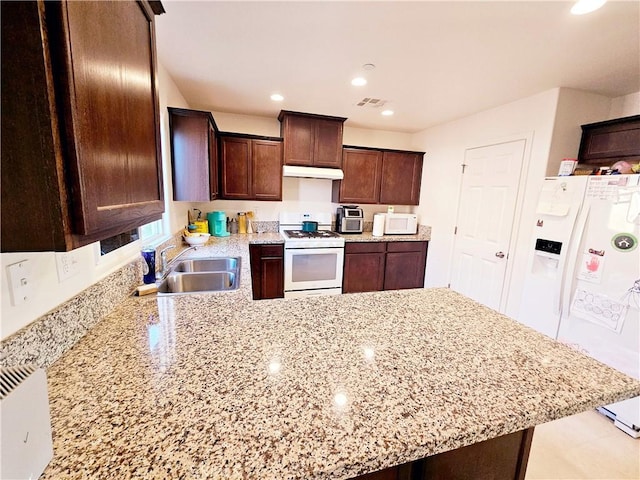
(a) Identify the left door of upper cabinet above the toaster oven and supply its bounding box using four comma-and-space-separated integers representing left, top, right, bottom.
333, 148, 382, 204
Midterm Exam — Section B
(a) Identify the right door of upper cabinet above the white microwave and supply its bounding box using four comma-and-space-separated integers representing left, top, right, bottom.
379, 152, 422, 205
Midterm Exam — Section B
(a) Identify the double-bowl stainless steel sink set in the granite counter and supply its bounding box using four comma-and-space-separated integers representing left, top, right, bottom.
158, 257, 241, 295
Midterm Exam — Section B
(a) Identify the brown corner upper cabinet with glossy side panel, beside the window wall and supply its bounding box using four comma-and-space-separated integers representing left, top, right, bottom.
169, 107, 219, 202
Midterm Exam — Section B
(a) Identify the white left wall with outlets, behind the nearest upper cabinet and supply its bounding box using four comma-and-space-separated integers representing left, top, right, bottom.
0, 65, 188, 339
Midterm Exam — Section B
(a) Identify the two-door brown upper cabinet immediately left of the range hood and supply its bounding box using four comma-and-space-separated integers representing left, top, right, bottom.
220, 133, 282, 200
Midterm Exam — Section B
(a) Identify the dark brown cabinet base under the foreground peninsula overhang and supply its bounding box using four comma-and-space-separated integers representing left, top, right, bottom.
355, 427, 533, 480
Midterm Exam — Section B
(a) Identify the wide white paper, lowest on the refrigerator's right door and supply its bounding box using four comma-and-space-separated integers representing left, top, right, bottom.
571, 289, 628, 333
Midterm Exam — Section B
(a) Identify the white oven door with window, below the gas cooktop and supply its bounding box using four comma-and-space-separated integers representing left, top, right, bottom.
284, 245, 344, 296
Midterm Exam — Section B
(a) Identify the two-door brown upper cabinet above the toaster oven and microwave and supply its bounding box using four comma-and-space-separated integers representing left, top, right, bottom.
333, 146, 424, 205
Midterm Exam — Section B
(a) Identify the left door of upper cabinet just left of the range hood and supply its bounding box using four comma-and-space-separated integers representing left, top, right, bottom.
220, 137, 252, 200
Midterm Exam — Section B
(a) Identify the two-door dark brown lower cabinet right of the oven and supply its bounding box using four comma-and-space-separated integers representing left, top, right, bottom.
342, 241, 428, 293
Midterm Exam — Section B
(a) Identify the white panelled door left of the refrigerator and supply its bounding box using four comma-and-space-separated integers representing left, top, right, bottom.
451, 139, 526, 310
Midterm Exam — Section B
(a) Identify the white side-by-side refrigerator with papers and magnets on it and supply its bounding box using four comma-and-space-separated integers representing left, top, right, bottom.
518, 175, 640, 438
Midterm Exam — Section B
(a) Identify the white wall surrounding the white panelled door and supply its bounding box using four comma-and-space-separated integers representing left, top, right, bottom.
414, 89, 559, 320
